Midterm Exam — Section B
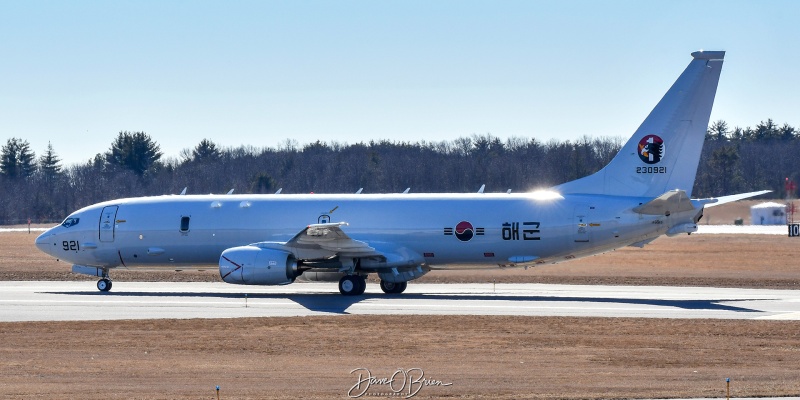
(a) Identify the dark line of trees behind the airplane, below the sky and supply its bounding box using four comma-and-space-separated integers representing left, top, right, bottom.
0, 120, 800, 225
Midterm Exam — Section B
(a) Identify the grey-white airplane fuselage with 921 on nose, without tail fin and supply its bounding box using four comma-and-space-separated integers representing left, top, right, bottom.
36, 192, 697, 269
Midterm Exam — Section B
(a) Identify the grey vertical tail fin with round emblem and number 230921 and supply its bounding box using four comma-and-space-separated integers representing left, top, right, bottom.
554, 51, 725, 197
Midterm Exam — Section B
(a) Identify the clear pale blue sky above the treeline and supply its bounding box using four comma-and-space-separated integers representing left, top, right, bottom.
0, 0, 800, 164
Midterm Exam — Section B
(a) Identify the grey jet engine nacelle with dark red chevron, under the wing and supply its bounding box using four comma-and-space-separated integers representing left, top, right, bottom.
219, 246, 300, 285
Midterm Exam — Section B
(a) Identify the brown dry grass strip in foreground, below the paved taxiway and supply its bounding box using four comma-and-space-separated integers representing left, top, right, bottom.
0, 316, 800, 399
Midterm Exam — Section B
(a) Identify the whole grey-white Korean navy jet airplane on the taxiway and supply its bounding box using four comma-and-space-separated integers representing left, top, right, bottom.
36, 51, 768, 295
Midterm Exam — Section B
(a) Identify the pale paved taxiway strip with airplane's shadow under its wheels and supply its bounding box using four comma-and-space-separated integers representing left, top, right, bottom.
0, 281, 800, 322
